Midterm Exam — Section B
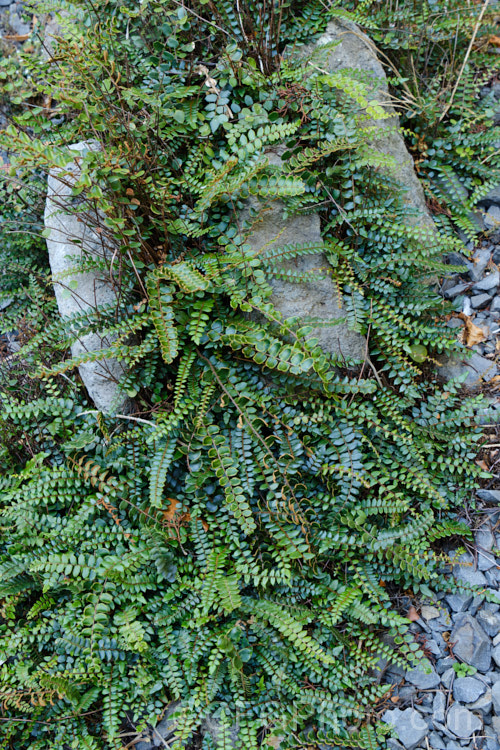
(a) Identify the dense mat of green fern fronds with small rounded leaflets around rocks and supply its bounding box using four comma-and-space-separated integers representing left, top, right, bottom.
0, 0, 492, 750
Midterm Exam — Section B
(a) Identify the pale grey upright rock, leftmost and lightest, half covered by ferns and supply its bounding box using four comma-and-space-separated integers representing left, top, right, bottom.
45, 142, 130, 413
